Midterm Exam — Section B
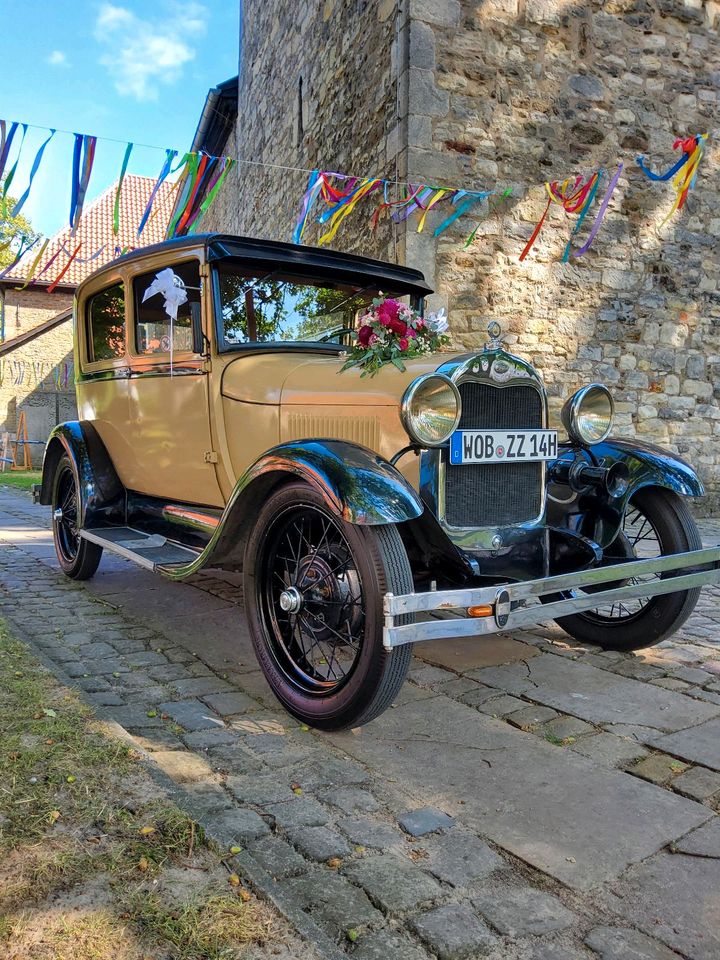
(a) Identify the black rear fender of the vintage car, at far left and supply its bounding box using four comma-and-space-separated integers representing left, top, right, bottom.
39, 420, 125, 528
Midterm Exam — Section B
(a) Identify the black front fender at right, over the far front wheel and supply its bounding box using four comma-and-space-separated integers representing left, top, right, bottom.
547, 437, 705, 547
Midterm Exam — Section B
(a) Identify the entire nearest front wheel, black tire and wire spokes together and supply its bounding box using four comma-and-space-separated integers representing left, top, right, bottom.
243, 482, 413, 730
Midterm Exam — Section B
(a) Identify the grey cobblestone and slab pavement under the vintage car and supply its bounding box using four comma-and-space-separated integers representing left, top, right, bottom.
0, 492, 720, 960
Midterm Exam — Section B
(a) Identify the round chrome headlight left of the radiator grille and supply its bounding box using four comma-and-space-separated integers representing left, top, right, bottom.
400, 373, 461, 447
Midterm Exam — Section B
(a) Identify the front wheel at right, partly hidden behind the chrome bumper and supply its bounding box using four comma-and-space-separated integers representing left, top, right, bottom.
556, 487, 702, 651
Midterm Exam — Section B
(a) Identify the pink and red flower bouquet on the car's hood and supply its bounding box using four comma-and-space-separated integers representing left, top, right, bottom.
340, 295, 450, 377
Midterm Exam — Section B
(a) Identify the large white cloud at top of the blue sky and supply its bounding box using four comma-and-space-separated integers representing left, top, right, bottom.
95, 2, 208, 100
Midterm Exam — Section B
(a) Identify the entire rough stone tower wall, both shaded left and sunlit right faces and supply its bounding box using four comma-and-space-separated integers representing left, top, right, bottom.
208, 0, 720, 509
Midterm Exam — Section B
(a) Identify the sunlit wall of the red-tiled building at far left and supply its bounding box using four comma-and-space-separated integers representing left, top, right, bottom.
0, 289, 77, 466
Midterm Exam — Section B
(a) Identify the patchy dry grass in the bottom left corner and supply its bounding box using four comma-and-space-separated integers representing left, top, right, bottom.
0, 620, 288, 960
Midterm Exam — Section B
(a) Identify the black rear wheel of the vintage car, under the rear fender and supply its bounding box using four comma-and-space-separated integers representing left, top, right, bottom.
52, 454, 102, 580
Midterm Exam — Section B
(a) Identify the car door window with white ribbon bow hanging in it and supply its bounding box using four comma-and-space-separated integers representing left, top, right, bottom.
133, 260, 201, 356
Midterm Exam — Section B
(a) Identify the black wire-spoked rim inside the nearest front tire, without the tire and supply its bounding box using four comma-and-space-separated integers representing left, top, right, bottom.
260, 506, 365, 696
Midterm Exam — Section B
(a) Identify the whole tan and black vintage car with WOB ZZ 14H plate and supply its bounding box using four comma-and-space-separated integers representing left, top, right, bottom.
37, 234, 720, 729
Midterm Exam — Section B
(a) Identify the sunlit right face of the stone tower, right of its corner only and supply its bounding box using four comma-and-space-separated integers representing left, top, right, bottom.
408, 0, 720, 508
